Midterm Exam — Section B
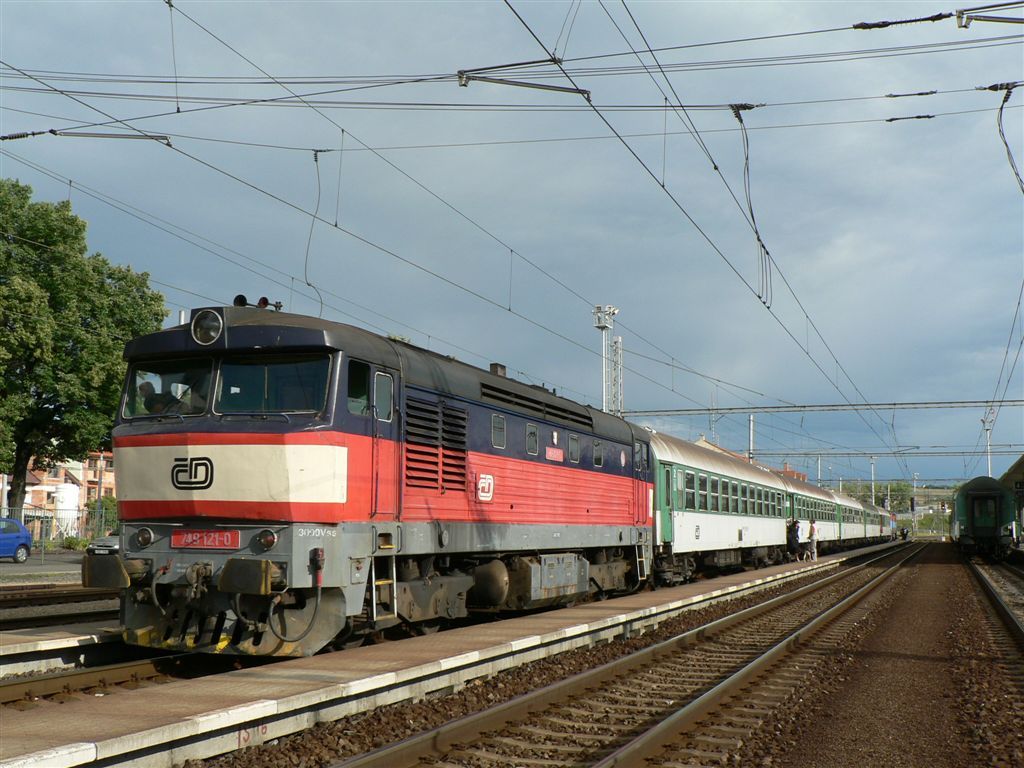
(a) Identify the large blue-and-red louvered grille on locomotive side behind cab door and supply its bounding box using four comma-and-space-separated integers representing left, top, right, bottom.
406, 397, 469, 490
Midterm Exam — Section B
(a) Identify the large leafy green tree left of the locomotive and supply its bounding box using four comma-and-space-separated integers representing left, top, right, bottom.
0, 179, 165, 514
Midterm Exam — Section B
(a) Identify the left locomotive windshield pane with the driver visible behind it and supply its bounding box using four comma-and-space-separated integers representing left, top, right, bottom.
124, 359, 213, 418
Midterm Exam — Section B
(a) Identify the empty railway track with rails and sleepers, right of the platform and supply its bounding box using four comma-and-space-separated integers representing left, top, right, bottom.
339, 547, 921, 768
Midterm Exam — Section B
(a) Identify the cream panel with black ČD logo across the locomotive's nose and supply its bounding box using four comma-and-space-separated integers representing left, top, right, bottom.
114, 444, 348, 504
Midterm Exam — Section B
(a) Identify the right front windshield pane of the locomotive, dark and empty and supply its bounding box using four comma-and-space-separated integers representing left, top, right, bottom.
213, 354, 331, 414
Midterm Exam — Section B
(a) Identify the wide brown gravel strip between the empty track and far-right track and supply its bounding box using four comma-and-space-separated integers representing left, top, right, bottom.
732, 545, 1024, 768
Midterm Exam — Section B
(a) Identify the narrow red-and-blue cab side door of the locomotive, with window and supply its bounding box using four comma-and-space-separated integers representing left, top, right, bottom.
371, 366, 401, 520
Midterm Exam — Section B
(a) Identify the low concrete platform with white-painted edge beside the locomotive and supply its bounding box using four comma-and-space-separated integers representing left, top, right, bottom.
0, 545, 889, 768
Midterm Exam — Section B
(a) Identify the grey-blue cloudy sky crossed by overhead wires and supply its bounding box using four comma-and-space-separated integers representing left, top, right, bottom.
0, 0, 1024, 482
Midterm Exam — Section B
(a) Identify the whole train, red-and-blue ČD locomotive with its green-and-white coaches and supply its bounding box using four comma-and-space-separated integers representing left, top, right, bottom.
82, 301, 894, 655
